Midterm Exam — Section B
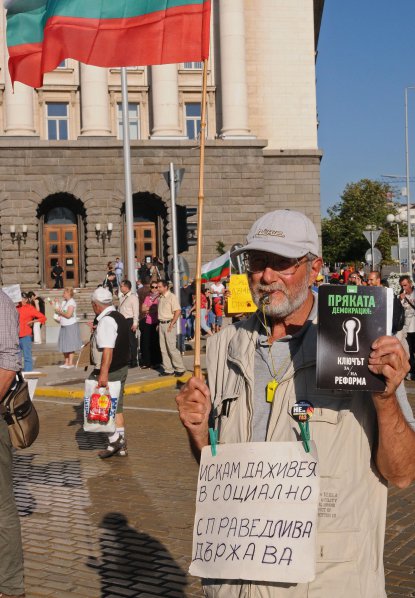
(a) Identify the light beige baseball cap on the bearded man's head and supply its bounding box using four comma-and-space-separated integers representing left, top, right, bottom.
231, 210, 319, 258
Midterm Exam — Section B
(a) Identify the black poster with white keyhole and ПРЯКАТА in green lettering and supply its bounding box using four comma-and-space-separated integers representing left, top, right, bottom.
317, 285, 391, 392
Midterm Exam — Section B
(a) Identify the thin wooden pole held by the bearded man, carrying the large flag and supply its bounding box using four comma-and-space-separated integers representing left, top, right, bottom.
193, 58, 208, 378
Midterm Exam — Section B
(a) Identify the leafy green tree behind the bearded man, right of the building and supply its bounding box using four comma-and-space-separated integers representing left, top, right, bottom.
321, 179, 406, 263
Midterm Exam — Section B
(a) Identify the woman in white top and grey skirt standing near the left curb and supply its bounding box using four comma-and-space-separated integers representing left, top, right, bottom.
55, 287, 82, 369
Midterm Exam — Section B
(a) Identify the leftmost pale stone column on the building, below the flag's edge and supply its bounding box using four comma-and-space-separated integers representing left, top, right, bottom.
4, 78, 35, 136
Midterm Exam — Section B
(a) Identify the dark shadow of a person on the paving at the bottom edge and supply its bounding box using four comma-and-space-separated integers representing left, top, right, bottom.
87, 512, 187, 598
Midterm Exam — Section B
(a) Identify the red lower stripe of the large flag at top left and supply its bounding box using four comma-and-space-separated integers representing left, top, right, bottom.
9, 3, 210, 87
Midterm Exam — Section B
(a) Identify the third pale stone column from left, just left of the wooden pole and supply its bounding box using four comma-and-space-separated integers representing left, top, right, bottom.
151, 64, 183, 139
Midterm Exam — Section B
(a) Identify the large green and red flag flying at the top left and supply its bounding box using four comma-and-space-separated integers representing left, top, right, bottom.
4, 0, 210, 87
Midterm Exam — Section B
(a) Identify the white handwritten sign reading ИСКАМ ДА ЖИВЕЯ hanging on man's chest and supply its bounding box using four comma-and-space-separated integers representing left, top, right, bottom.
189, 442, 320, 583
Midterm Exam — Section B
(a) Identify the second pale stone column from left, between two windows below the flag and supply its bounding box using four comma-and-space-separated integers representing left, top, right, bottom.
81, 63, 111, 137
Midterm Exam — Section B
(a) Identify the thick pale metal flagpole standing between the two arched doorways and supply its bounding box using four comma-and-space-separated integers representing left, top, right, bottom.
121, 67, 137, 293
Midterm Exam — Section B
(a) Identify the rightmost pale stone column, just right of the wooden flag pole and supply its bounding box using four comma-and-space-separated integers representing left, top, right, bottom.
219, 0, 252, 138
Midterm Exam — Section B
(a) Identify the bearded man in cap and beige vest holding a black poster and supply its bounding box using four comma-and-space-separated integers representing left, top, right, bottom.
176, 210, 415, 598
